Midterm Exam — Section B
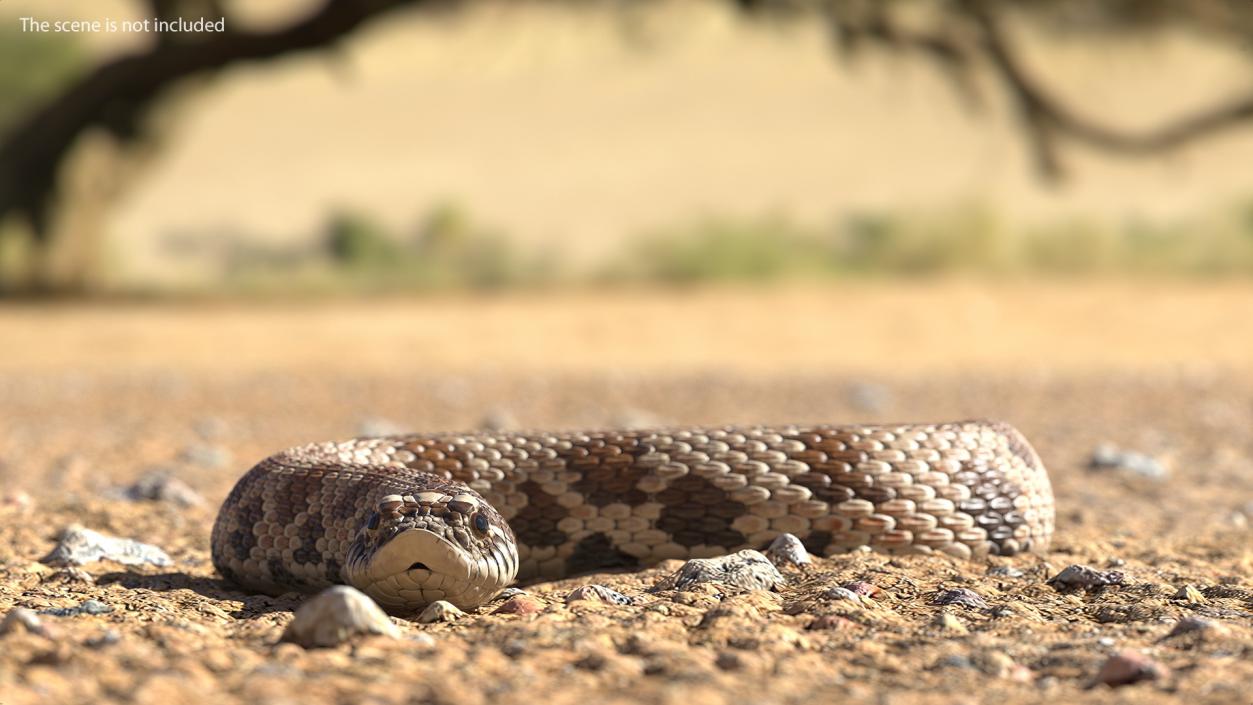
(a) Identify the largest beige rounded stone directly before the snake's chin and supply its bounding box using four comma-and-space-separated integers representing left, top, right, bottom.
279, 585, 401, 649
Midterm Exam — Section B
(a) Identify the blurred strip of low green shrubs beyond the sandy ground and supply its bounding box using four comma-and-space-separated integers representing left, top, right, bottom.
210, 199, 1253, 296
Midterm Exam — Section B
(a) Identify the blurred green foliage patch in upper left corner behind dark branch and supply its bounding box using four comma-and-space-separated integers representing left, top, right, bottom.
0, 23, 88, 134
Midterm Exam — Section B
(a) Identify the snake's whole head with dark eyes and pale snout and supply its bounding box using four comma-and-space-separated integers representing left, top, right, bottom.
343, 487, 517, 611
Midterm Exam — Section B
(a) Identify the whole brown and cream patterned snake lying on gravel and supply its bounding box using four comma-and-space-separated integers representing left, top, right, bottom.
211, 421, 1054, 612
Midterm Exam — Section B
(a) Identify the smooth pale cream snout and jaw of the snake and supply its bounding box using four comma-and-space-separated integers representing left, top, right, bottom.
353, 528, 517, 610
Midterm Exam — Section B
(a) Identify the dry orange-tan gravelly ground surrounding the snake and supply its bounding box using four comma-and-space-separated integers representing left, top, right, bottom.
0, 284, 1253, 705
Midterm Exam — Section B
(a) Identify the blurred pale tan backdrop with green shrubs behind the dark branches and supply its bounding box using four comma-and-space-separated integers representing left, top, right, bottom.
7, 0, 1253, 294
